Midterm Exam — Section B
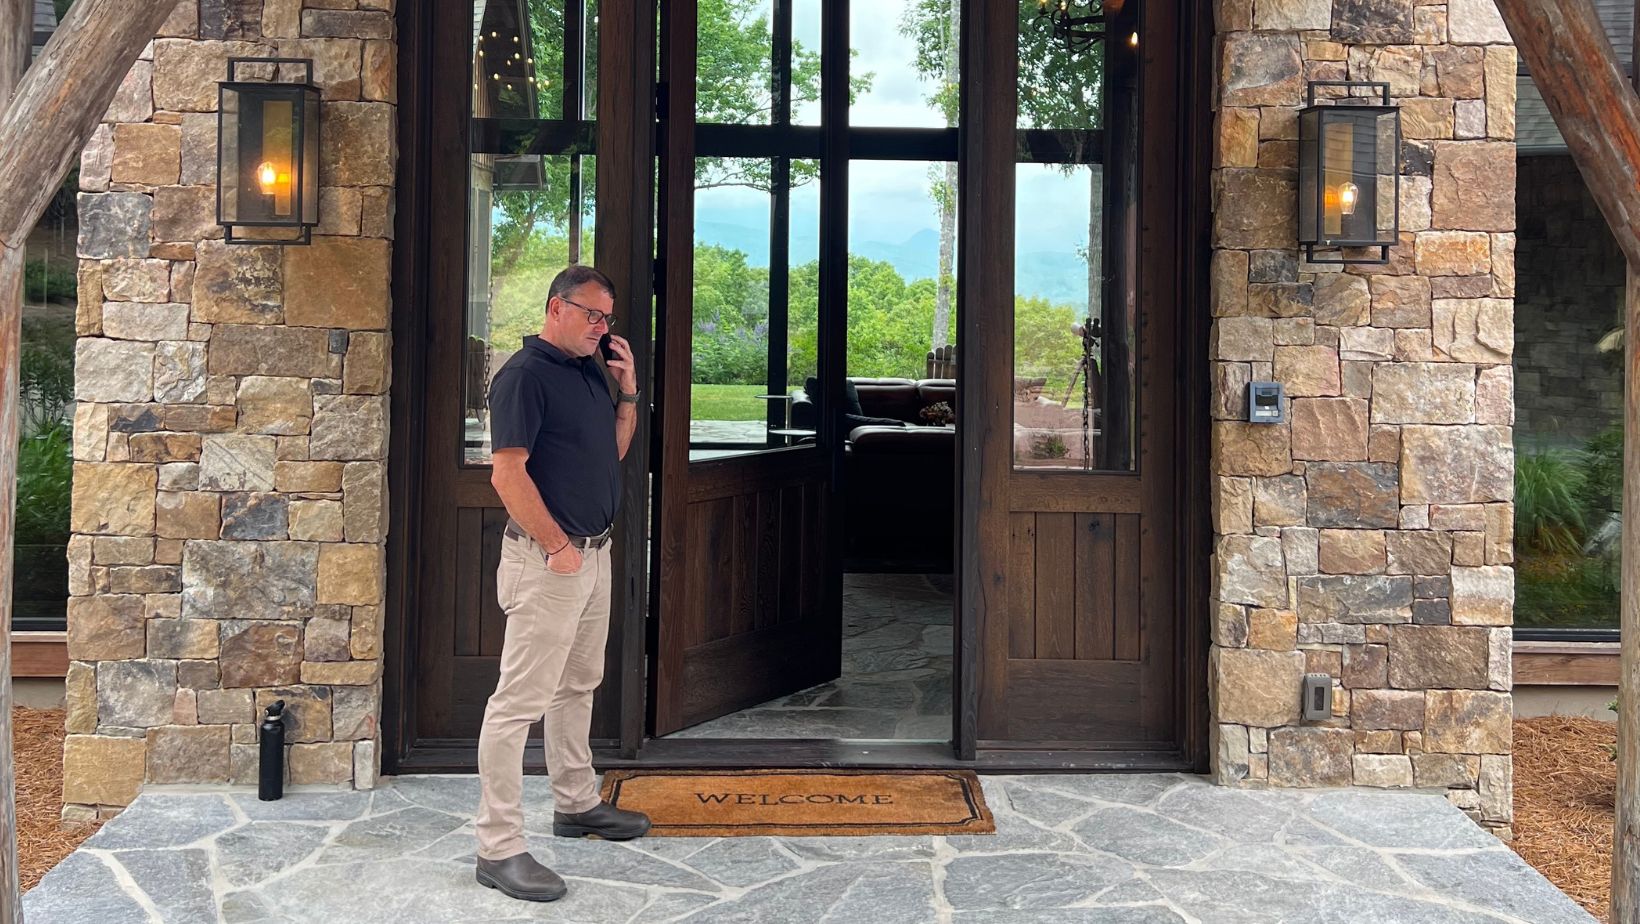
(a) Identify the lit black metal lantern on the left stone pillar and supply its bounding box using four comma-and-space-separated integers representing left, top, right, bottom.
216, 57, 320, 245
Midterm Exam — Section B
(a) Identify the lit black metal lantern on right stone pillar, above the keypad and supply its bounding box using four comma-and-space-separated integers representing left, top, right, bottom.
1299, 80, 1401, 263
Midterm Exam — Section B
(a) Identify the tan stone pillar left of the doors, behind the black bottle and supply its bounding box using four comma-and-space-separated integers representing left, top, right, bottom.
62, 0, 397, 817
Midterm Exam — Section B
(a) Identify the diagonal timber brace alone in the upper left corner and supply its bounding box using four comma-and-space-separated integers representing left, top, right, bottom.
0, 0, 177, 251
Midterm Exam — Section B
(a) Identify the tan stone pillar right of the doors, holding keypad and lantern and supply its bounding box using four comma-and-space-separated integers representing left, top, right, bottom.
1210, 0, 1515, 835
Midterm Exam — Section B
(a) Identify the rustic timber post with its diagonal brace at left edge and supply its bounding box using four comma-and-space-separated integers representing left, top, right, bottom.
0, 0, 177, 922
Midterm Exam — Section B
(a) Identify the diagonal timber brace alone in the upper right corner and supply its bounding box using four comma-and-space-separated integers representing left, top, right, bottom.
1502, 0, 1640, 266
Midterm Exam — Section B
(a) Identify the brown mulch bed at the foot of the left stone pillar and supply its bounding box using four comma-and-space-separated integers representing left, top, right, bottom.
11, 706, 100, 891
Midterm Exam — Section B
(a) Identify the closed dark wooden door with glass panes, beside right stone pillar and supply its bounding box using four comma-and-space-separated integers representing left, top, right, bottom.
958, 0, 1205, 768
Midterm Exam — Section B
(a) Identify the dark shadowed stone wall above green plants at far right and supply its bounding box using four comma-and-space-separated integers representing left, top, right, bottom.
1515, 154, 1624, 448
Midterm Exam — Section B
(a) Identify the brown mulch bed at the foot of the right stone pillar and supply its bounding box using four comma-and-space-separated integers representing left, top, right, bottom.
1510, 716, 1617, 921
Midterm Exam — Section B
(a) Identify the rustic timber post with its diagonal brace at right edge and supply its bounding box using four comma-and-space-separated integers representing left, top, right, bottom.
1497, 0, 1640, 922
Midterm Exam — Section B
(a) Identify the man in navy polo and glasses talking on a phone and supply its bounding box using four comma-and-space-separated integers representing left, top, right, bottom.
477, 266, 649, 901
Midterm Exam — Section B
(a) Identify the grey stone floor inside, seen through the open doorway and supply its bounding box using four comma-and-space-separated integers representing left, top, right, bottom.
667, 574, 956, 742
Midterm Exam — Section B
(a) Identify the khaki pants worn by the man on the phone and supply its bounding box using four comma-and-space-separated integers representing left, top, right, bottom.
477, 535, 610, 860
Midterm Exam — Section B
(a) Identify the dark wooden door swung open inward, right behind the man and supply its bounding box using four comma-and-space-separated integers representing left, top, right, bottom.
649, 2, 846, 735
